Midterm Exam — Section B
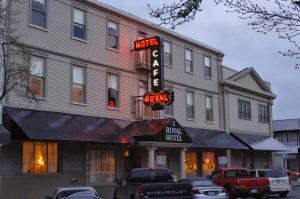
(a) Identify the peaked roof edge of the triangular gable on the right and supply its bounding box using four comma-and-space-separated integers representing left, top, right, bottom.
227, 67, 272, 93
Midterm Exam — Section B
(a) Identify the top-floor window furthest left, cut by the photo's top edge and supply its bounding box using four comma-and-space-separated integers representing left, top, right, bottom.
31, 0, 46, 28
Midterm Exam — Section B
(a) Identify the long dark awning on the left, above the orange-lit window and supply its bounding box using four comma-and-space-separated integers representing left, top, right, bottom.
3, 107, 121, 143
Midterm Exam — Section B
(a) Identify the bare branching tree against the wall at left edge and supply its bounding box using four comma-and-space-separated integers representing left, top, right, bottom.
0, 0, 33, 102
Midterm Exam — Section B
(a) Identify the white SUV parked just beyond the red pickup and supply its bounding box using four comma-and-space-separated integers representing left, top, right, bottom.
250, 169, 291, 198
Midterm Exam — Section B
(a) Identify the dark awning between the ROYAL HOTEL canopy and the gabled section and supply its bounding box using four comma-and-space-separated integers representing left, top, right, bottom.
185, 127, 248, 149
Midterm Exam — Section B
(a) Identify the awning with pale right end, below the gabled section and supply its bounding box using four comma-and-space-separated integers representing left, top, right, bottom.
230, 132, 289, 151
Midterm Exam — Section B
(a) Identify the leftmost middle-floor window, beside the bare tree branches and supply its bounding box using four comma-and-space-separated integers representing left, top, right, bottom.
29, 57, 45, 97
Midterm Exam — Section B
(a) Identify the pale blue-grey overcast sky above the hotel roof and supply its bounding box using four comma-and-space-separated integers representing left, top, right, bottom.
100, 0, 300, 119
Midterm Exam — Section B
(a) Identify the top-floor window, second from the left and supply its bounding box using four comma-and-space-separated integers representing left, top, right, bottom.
73, 8, 86, 40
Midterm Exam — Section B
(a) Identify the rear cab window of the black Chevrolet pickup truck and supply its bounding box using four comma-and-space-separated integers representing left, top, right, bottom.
129, 169, 173, 183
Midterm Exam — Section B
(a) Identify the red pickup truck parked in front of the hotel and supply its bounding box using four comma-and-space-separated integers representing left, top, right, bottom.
211, 168, 269, 199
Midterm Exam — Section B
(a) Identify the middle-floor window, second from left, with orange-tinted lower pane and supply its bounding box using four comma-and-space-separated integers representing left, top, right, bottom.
71, 66, 85, 104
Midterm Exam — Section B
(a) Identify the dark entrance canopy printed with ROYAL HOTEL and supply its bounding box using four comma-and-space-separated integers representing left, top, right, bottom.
121, 118, 192, 143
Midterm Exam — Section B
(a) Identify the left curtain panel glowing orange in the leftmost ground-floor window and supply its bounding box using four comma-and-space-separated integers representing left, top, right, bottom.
23, 142, 34, 173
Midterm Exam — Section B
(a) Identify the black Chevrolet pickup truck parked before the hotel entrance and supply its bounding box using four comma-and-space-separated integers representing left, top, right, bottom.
113, 168, 193, 199
